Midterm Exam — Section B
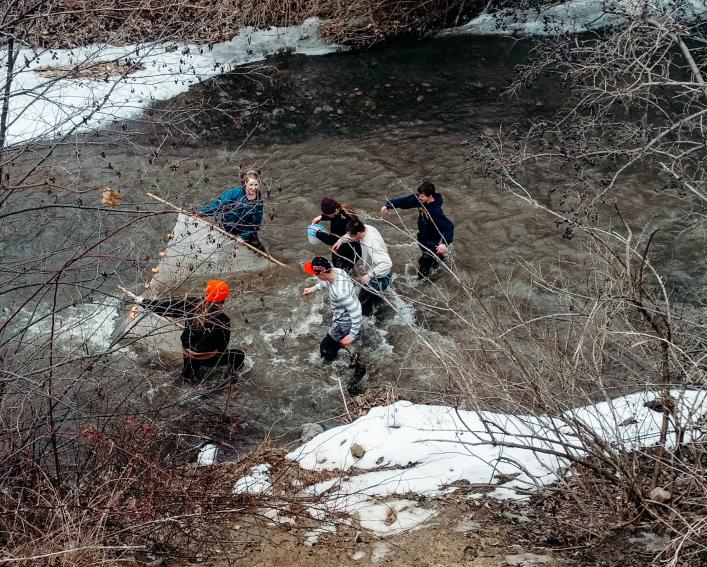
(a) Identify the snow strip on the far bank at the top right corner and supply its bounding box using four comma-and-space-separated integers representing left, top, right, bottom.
438, 0, 707, 36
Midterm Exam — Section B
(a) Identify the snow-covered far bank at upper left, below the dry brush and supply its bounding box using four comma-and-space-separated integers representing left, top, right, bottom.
0, 18, 341, 145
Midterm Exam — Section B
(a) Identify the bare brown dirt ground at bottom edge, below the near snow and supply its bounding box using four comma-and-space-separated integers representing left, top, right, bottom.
209, 494, 564, 567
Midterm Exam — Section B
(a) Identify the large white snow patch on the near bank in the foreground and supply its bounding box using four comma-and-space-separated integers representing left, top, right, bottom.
234, 390, 707, 535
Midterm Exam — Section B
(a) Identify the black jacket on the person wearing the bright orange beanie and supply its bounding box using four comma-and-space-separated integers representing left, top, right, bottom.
140, 298, 231, 352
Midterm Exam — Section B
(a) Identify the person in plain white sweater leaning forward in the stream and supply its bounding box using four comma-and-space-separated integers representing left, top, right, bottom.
332, 219, 393, 316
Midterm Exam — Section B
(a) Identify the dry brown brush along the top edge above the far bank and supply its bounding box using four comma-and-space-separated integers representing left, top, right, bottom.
6, 0, 481, 47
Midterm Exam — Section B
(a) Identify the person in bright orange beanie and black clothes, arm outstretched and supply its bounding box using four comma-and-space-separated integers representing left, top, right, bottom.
134, 280, 245, 381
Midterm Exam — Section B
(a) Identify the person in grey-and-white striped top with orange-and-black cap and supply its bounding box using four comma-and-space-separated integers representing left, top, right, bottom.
303, 256, 361, 361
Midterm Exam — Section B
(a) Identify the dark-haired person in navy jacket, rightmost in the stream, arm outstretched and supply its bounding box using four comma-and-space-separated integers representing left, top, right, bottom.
381, 181, 454, 278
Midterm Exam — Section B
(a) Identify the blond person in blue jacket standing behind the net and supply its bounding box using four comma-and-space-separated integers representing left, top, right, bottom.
197, 170, 265, 251
